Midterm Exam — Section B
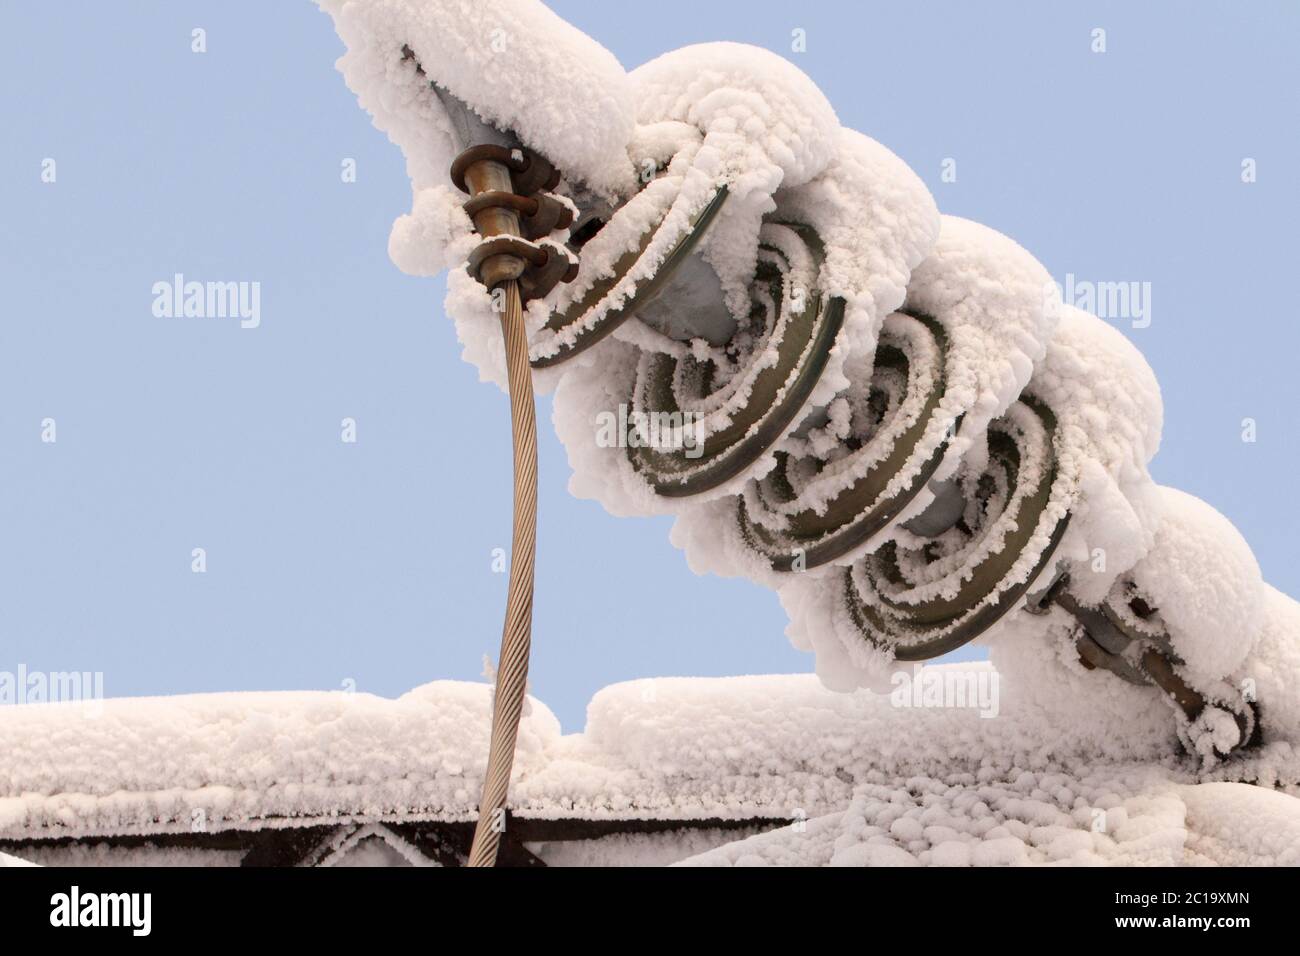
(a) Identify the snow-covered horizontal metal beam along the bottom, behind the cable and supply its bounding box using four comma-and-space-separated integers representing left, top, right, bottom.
0, 665, 1300, 866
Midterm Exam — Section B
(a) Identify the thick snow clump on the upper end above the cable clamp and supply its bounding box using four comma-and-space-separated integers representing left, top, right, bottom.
319, 0, 637, 388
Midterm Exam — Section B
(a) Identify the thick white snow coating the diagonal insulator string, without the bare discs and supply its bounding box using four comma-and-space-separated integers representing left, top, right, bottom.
314, 13, 1292, 717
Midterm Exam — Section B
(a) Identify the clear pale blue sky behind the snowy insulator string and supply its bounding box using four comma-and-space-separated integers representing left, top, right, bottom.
0, 0, 1300, 730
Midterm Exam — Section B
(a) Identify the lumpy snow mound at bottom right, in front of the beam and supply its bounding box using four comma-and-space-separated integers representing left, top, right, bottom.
681, 770, 1300, 866
